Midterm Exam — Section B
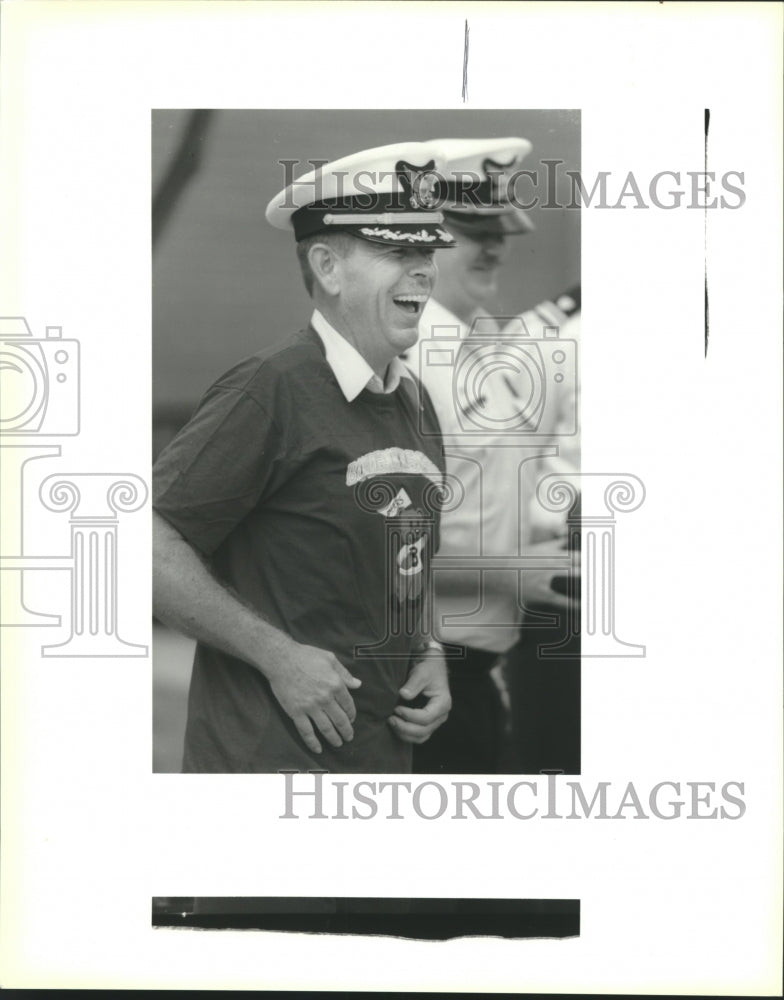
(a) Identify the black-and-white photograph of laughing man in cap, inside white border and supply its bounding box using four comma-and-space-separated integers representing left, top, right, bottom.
152, 110, 581, 774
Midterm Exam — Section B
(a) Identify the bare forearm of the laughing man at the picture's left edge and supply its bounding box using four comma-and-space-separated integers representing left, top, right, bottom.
153, 512, 293, 677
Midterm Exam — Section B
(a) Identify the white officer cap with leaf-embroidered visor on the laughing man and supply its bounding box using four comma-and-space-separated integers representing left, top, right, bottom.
266, 142, 456, 249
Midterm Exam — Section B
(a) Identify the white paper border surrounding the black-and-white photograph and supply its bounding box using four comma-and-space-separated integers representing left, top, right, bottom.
0, 0, 781, 994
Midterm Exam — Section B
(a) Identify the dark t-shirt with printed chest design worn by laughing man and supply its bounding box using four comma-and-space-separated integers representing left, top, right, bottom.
153, 330, 444, 773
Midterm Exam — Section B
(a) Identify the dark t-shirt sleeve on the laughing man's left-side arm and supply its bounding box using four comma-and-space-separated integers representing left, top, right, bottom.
153, 385, 286, 556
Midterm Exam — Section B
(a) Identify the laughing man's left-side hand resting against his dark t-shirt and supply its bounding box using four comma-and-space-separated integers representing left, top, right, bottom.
267, 641, 362, 753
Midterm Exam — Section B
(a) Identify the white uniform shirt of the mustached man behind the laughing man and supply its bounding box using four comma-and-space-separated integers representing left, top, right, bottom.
405, 299, 534, 653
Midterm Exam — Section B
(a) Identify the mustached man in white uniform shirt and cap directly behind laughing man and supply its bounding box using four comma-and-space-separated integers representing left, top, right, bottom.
405, 138, 580, 774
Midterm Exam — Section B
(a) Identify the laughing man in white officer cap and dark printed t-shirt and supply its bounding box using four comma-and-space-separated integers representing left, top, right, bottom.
154, 143, 455, 773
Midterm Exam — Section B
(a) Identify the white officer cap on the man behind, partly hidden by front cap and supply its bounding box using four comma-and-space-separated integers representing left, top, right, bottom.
433, 136, 536, 236
